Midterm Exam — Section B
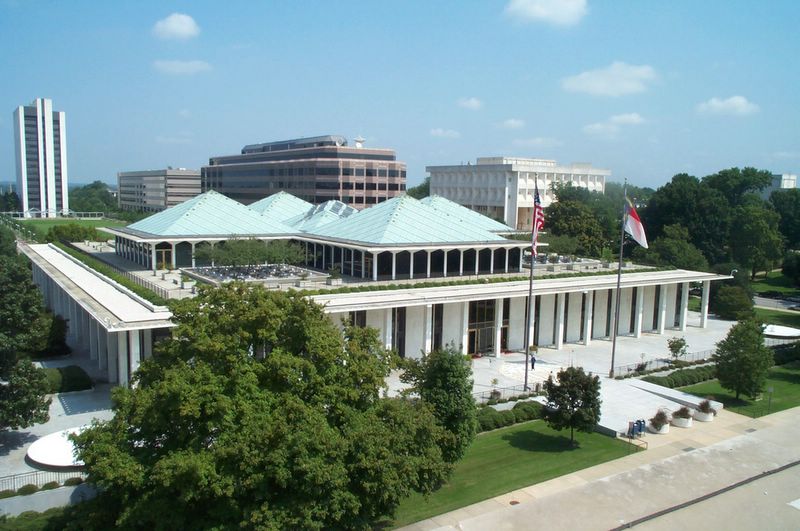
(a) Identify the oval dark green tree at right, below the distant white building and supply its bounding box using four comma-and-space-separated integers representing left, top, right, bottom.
731, 200, 783, 278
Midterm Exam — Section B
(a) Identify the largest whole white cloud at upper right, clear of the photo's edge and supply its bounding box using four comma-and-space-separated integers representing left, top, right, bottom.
561, 61, 656, 96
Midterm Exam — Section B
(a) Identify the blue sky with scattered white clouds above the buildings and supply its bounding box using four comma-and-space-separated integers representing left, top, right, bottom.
0, 0, 800, 187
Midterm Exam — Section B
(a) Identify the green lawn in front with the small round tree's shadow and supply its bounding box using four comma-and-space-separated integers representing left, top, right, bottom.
393, 421, 633, 527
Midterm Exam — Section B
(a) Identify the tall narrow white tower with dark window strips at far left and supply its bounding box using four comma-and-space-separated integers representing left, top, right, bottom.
14, 98, 69, 217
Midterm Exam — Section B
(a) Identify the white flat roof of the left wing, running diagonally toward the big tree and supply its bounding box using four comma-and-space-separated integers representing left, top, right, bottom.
20, 244, 174, 332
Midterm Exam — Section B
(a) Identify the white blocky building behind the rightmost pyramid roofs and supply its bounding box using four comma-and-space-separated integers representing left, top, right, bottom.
426, 157, 611, 229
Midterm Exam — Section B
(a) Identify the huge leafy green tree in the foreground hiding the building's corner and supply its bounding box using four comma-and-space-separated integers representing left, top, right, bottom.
75, 283, 450, 529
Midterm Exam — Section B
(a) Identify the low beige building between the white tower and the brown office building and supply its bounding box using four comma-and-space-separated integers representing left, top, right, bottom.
117, 168, 200, 212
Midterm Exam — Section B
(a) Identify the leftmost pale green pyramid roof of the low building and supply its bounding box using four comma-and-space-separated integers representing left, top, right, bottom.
126, 190, 296, 236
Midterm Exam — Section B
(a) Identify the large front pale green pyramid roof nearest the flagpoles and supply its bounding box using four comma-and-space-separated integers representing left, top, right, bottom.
309, 195, 505, 245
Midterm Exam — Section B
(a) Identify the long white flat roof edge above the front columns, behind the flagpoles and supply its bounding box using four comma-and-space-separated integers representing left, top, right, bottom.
310, 269, 731, 313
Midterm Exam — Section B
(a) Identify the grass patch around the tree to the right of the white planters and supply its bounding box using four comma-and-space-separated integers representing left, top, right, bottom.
681, 362, 800, 417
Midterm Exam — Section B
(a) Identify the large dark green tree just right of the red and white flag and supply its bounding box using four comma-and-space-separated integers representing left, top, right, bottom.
640, 173, 731, 264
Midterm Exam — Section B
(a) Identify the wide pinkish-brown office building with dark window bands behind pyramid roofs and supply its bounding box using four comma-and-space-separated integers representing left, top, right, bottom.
201, 135, 406, 209
